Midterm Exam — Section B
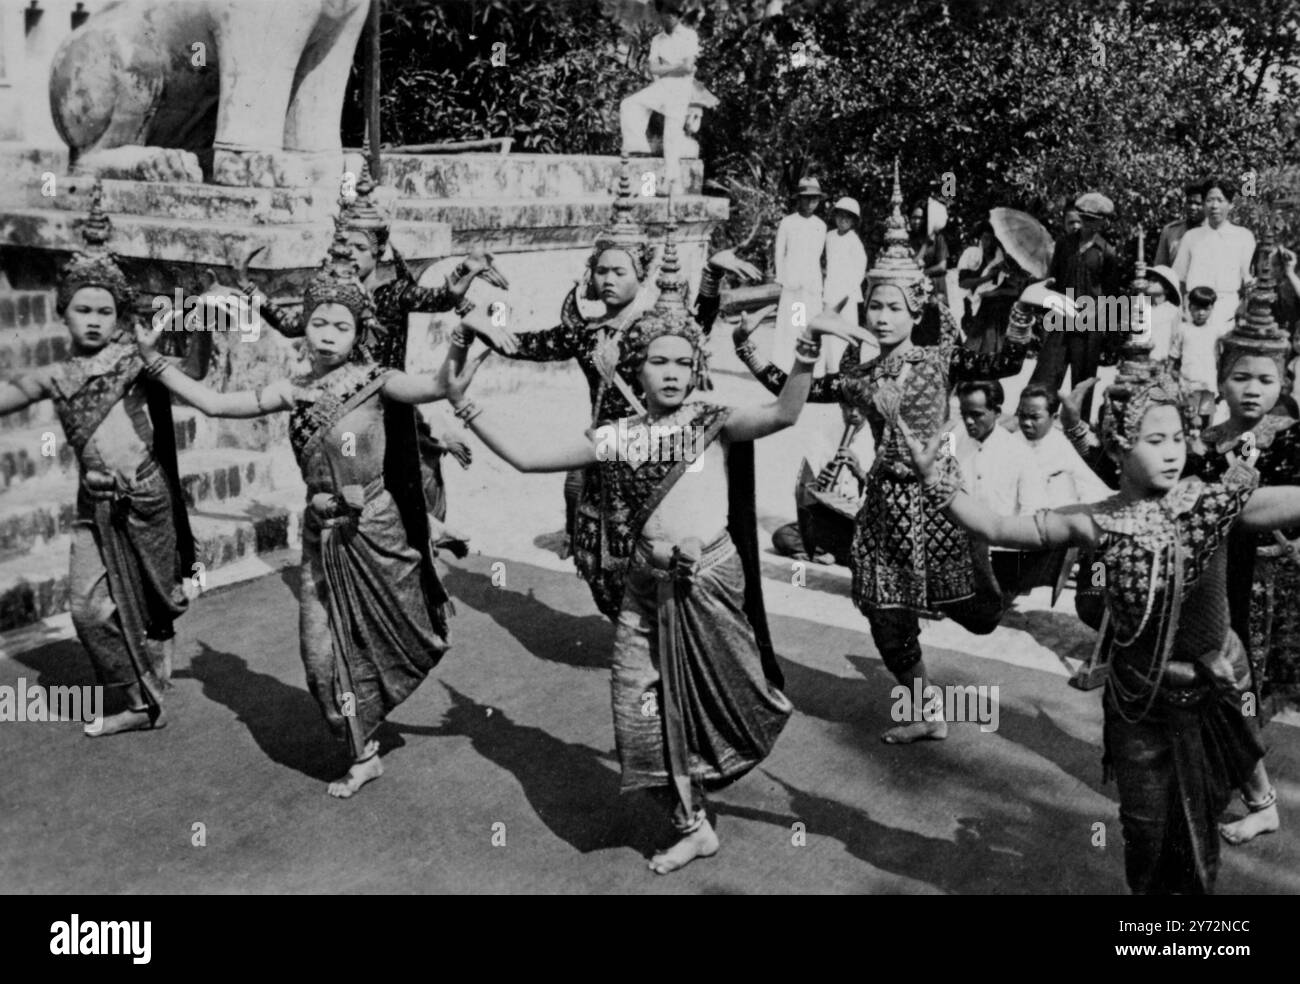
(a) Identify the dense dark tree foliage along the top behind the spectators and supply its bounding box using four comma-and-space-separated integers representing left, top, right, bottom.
351, 0, 1300, 257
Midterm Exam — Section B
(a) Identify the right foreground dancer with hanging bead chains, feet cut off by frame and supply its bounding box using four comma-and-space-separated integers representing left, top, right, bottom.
906, 330, 1300, 894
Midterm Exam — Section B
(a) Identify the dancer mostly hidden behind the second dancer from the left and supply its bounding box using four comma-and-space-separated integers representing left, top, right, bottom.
239, 164, 515, 545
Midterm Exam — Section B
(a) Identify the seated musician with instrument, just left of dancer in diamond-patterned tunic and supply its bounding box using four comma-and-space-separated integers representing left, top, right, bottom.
772, 377, 875, 567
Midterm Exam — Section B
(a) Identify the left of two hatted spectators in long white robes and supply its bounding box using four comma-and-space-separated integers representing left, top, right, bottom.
772, 178, 826, 369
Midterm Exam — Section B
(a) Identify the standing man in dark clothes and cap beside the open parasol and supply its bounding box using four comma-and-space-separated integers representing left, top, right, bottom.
1030, 191, 1119, 420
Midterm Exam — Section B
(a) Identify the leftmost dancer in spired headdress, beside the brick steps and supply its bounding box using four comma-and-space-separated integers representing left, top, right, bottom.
0, 182, 201, 736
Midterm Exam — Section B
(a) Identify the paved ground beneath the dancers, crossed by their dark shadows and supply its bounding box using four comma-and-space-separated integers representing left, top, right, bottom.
0, 335, 1300, 894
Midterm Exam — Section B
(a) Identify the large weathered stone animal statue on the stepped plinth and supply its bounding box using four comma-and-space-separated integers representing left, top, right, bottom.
49, 0, 369, 185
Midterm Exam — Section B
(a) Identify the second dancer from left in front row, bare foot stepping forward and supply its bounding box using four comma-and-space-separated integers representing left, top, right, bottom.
137, 220, 447, 797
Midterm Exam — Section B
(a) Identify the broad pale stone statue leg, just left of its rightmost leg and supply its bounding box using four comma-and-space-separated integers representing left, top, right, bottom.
212, 0, 320, 151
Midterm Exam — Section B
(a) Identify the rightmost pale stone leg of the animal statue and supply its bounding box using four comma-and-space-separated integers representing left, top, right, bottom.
283, 0, 371, 152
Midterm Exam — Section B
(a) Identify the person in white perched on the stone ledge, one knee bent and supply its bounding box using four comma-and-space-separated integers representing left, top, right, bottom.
619, 0, 699, 196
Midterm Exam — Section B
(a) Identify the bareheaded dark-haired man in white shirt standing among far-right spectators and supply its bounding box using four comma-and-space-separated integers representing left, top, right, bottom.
1174, 178, 1255, 337
